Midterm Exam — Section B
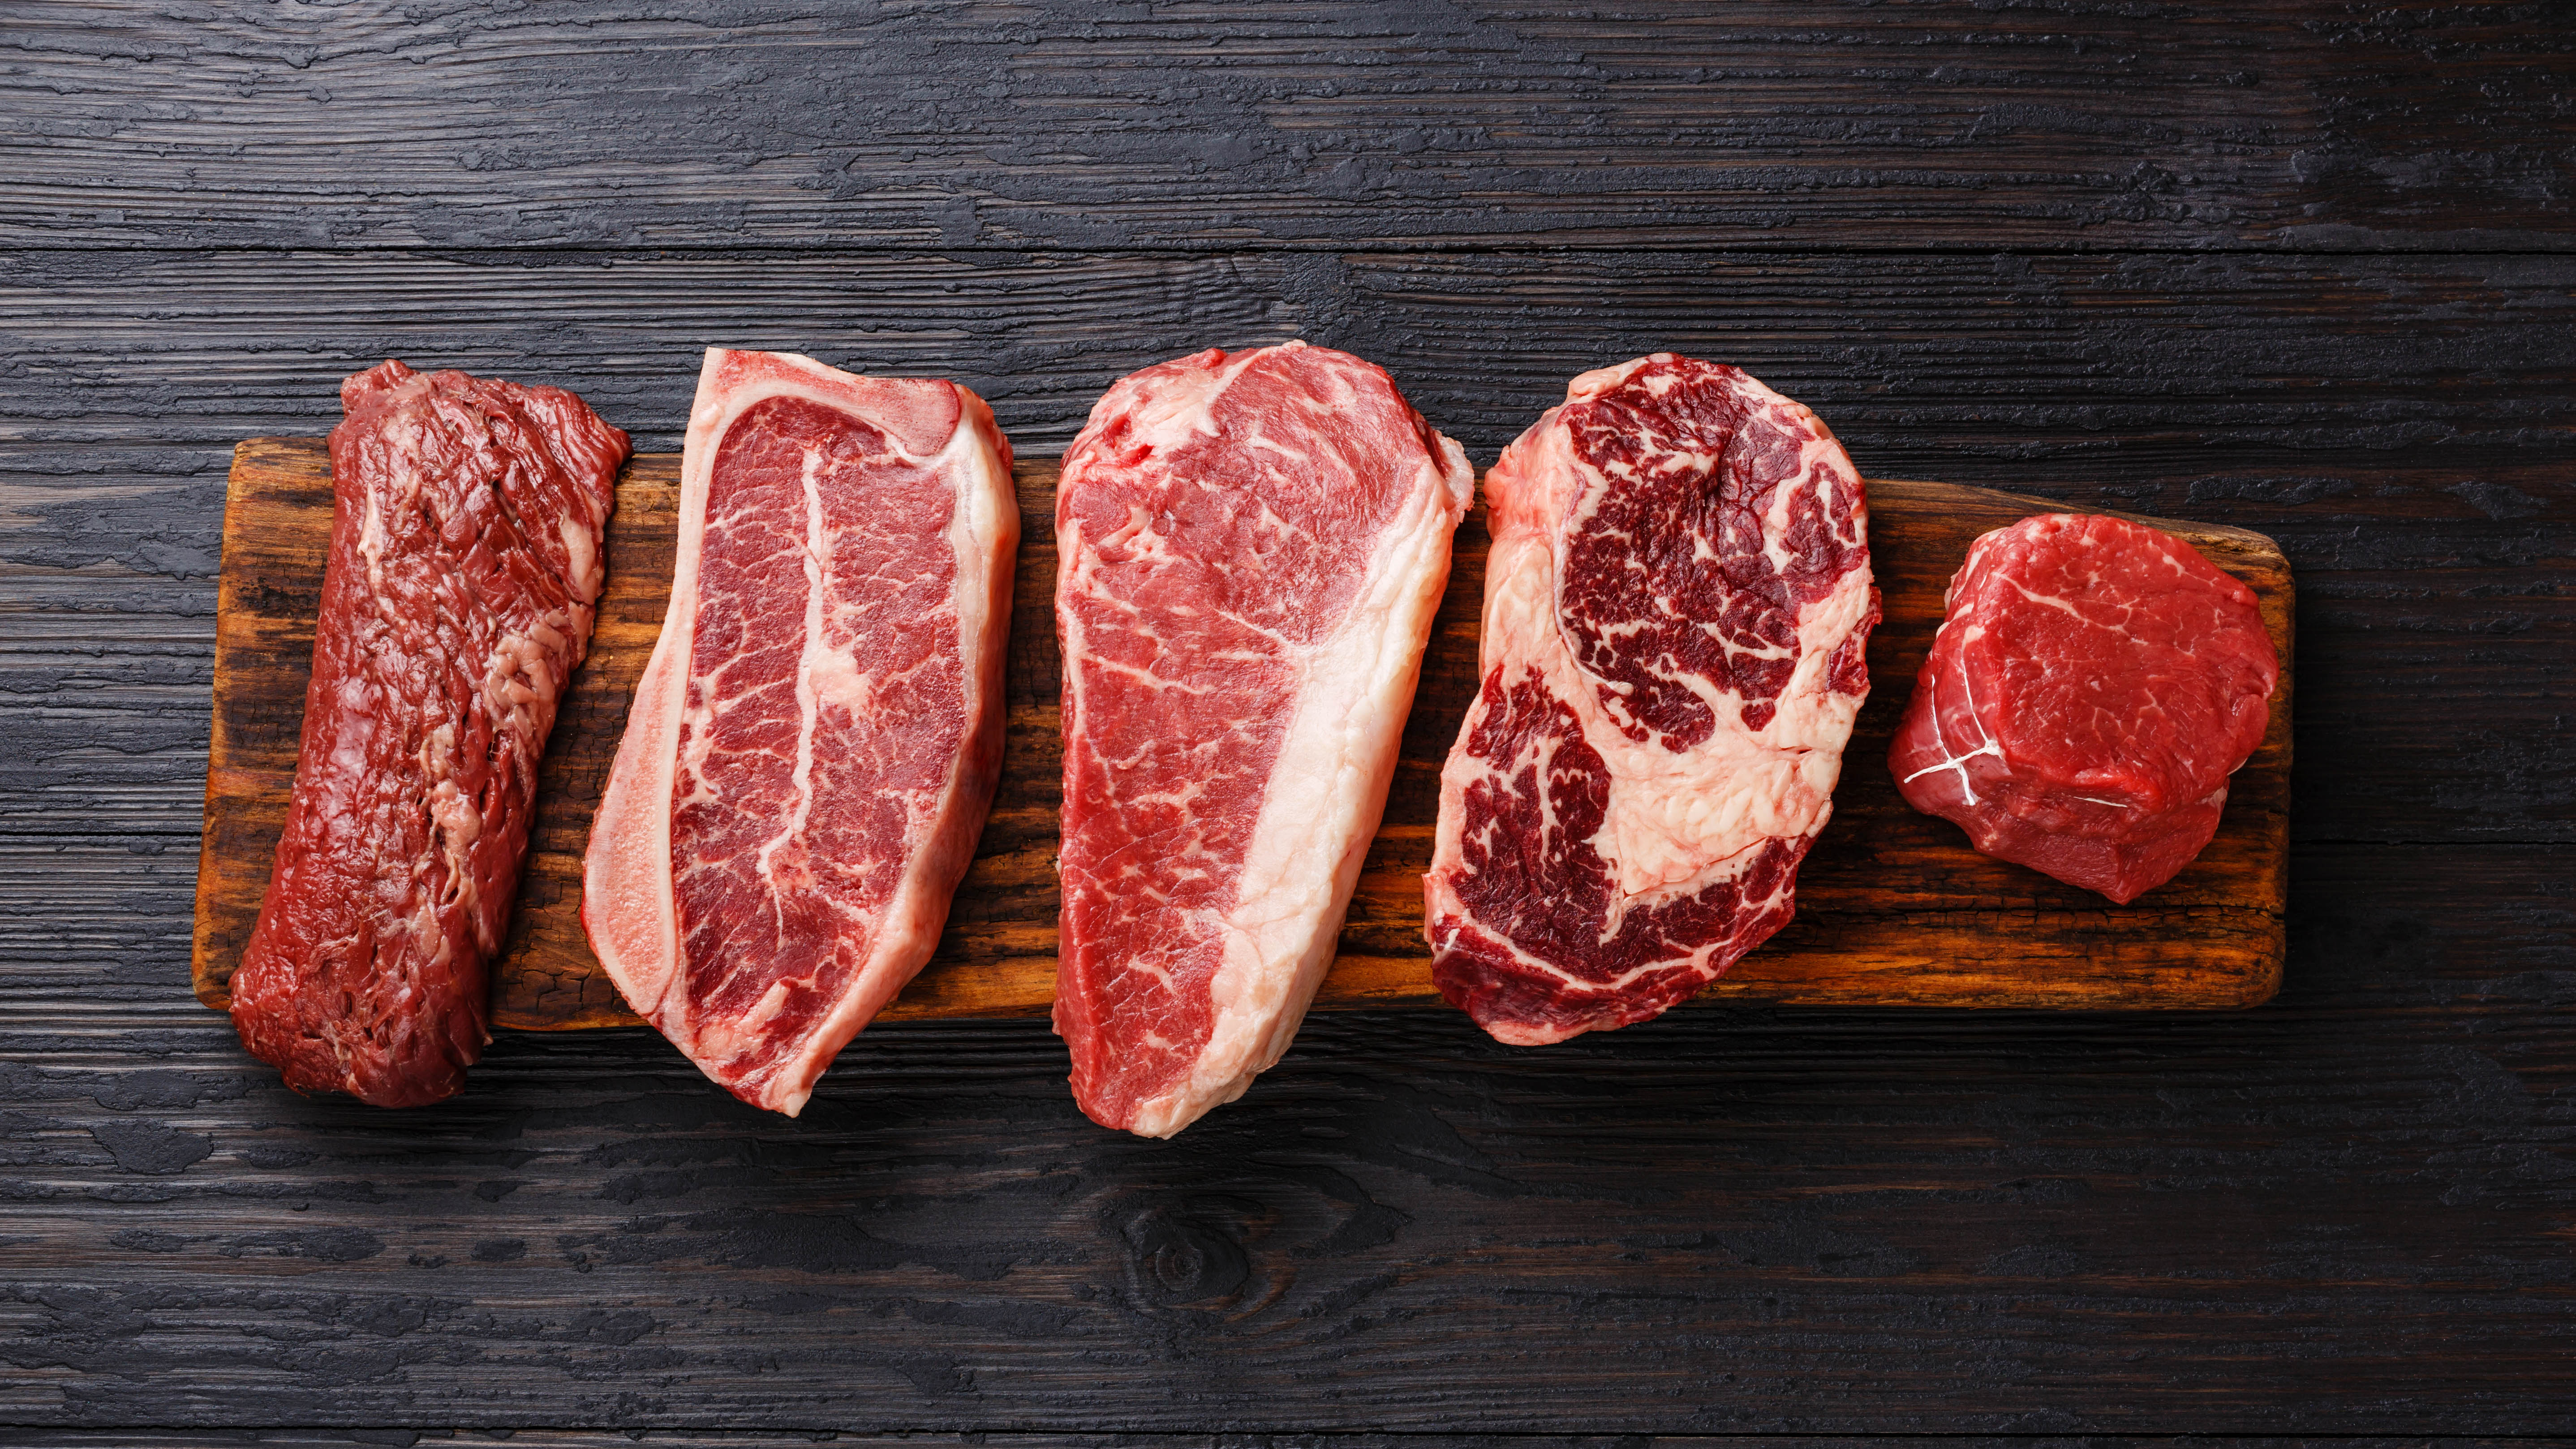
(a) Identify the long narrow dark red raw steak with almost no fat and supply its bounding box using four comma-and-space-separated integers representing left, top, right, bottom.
232, 363, 626, 1107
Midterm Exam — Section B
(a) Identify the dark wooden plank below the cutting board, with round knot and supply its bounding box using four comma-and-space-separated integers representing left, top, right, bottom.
0, 847, 2576, 1444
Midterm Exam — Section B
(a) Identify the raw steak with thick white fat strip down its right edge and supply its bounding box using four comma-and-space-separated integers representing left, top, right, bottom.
1056, 342, 1476, 1138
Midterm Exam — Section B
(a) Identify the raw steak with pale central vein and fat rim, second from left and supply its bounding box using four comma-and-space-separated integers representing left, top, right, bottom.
582, 348, 1020, 1117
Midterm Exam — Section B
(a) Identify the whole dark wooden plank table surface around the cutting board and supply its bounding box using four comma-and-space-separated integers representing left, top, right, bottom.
0, 0, 2576, 1446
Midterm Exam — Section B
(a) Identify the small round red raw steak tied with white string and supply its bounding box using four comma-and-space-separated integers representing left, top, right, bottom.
1888, 512, 2280, 903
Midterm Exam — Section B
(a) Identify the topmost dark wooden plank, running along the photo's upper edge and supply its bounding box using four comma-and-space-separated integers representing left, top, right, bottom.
0, 0, 2576, 249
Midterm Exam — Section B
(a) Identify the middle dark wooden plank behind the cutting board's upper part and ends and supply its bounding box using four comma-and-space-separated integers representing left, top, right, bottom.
0, 252, 2576, 849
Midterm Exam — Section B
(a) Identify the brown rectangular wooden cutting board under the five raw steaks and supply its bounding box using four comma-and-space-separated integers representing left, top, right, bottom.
193, 438, 2292, 1029
